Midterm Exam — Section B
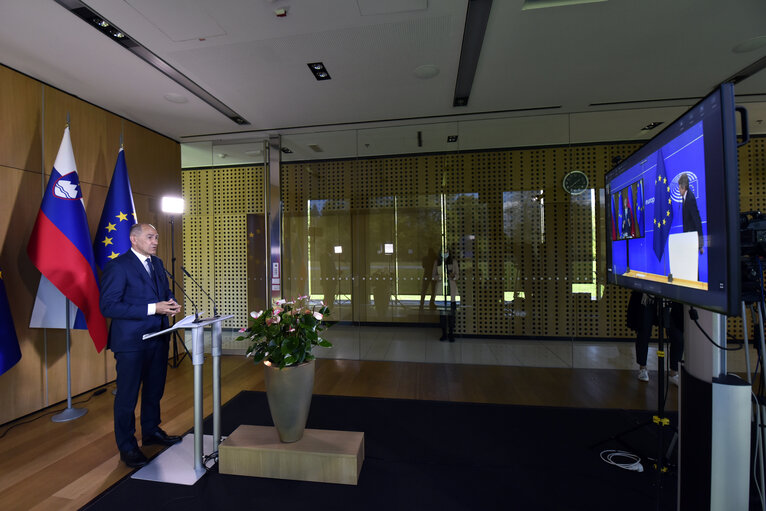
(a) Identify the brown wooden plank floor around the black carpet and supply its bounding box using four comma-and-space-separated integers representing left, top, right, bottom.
0, 356, 677, 511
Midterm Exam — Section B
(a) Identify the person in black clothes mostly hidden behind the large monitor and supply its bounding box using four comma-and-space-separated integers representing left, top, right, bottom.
627, 291, 684, 386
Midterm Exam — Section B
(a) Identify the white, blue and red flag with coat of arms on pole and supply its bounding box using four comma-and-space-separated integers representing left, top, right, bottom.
27, 126, 107, 352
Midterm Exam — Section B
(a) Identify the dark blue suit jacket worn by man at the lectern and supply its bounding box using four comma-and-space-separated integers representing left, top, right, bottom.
100, 250, 175, 352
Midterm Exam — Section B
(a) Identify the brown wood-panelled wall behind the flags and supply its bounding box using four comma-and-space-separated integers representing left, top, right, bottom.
0, 66, 183, 423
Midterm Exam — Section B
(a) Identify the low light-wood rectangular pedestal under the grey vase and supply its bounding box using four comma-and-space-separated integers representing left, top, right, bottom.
218, 424, 364, 485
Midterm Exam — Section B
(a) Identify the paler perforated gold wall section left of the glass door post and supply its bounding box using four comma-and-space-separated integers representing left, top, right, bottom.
182, 166, 264, 328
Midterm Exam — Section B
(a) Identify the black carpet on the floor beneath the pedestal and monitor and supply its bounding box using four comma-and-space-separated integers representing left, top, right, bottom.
83, 392, 676, 511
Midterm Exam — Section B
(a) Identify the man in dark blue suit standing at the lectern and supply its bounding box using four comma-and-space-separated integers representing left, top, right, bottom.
101, 224, 181, 468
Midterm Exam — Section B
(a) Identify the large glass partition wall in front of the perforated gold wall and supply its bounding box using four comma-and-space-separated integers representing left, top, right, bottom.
182, 111, 748, 368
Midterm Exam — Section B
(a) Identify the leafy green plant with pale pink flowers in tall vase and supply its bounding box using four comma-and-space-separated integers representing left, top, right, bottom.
236, 296, 332, 369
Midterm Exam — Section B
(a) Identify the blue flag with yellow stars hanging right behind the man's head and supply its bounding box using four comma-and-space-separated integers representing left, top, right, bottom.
93, 148, 137, 270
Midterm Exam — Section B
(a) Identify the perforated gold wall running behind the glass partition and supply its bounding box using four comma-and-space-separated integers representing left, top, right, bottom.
184, 138, 766, 339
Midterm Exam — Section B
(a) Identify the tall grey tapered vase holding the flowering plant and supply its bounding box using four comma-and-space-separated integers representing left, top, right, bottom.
263, 360, 314, 443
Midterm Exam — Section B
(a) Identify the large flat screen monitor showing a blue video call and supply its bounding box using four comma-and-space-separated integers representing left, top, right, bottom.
605, 84, 741, 315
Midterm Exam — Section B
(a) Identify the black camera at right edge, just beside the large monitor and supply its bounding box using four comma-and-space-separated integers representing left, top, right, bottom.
739, 211, 766, 303
